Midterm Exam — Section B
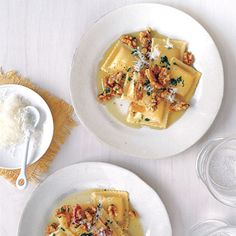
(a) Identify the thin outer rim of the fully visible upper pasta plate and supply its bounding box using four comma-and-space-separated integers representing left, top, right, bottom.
70, 3, 224, 159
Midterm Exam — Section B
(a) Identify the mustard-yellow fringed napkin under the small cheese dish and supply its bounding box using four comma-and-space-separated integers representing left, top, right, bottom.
0, 71, 76, 184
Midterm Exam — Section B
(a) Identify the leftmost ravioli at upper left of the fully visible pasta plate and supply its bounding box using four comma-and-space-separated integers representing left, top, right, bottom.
101, 41, 137, 73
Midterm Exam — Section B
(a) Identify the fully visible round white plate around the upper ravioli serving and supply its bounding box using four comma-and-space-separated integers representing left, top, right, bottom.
70, 3, 224, 158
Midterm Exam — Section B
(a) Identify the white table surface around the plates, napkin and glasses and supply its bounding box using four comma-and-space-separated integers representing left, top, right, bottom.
0, 0, 236, 236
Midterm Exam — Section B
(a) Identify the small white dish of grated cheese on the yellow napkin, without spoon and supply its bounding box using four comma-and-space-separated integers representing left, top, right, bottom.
0, 84, 54, 169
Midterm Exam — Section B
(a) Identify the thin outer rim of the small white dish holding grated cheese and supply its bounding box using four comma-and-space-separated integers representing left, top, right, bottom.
0, 84, 54, 170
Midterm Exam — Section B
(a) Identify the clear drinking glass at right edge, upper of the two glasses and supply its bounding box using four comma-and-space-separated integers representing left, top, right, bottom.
196, 137, 236, 207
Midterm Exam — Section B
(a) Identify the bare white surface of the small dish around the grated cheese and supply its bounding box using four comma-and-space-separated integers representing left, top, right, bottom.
0, 84, 54, 169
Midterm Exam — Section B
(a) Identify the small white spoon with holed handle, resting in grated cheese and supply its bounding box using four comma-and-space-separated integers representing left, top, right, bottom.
16, 106, 40, 190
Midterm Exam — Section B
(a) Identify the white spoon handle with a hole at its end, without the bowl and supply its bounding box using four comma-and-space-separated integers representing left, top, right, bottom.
16, 132, 31, 190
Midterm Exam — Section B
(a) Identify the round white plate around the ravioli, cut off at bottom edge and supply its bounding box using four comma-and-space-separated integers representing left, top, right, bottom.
18, 162, 172, 236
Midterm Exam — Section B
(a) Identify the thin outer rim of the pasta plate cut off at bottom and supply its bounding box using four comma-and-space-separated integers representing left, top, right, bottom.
17, 161, 172, 236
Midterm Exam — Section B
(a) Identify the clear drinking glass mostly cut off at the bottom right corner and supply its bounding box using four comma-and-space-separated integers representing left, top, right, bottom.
188, 220, 236, 236
